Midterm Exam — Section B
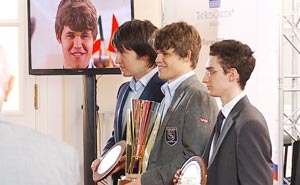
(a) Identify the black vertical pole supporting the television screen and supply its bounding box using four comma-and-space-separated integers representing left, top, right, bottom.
82, 75, 99, 185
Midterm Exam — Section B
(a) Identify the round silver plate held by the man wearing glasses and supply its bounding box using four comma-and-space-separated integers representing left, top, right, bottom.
178, 156, 207, 185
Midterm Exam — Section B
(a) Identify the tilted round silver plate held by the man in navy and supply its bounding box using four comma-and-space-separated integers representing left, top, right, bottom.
93, 141, 126, 182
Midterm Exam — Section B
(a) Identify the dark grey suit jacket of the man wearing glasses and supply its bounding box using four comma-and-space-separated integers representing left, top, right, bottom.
204, 96, 273, 185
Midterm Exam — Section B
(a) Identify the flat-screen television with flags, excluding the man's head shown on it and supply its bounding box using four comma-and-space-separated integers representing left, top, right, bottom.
27, 0, 134, 75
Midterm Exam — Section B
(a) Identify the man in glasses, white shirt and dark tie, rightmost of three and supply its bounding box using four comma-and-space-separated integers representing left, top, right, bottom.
203, 40, 273, 185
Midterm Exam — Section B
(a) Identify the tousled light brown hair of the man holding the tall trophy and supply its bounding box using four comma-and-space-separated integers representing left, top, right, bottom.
153, 22, 201, 69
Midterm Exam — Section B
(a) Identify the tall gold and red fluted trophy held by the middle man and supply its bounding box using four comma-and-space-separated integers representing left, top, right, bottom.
118, 99, 161, 185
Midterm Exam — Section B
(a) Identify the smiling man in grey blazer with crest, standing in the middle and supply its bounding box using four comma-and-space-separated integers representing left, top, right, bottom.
127, 22, 218, 185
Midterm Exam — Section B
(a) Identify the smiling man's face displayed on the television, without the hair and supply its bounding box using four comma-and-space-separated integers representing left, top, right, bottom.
57, 26, 94, 69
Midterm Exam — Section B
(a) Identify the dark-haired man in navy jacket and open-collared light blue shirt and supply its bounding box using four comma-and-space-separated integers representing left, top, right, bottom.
92, 20, 165, 185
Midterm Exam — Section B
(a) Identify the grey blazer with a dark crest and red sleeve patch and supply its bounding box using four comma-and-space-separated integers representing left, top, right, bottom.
142, 75, 218, 185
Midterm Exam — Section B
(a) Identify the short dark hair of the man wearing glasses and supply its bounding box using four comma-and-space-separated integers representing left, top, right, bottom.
209, 40, 256, 89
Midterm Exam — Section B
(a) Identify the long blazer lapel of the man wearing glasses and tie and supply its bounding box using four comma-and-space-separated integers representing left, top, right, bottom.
208, 96, 249, 168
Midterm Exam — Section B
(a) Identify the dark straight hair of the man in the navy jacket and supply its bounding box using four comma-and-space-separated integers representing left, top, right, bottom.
112, 20, 157, 67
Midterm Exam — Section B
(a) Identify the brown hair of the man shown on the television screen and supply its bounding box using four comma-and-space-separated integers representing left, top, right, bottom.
55, 0, 98, 40
